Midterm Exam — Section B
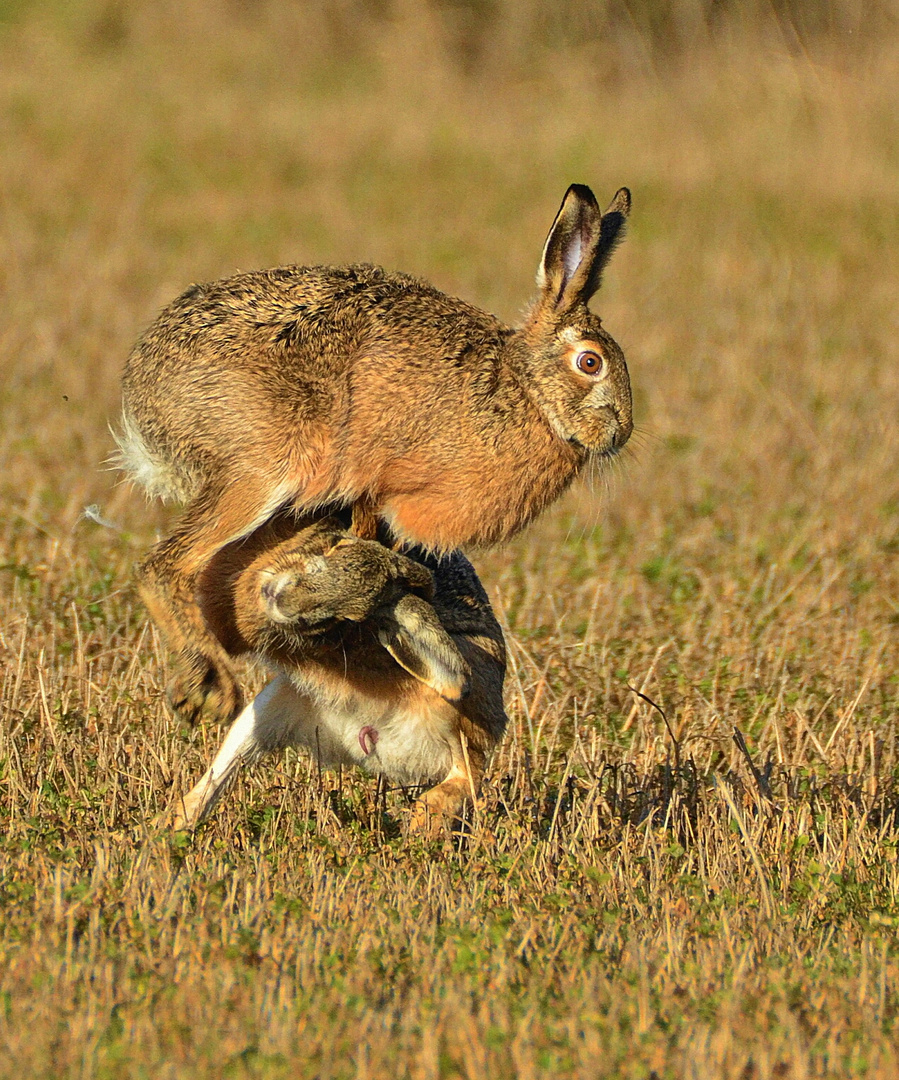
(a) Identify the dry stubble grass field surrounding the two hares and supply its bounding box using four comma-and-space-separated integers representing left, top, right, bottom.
0, 0, 899, 1080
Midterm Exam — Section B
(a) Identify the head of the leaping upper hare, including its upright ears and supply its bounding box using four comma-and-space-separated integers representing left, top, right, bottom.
516, 184, 633, 456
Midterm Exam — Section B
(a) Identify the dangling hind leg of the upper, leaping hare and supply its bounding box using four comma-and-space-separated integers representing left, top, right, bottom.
138, 478, 287, 723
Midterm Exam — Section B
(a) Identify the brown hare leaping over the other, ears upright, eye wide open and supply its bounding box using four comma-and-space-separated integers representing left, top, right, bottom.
118, 185, 632, 719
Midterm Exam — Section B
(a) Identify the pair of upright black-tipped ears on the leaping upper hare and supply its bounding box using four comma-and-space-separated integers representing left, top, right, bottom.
537, 184, 631, 312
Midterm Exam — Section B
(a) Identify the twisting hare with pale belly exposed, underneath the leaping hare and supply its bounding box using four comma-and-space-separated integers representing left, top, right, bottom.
174, 517, 506, 834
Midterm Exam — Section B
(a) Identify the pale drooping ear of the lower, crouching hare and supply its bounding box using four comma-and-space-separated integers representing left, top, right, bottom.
378, 594, 470, 701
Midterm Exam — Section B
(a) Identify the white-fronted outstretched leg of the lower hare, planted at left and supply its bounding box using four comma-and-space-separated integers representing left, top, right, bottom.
172, 675, 303, 831
